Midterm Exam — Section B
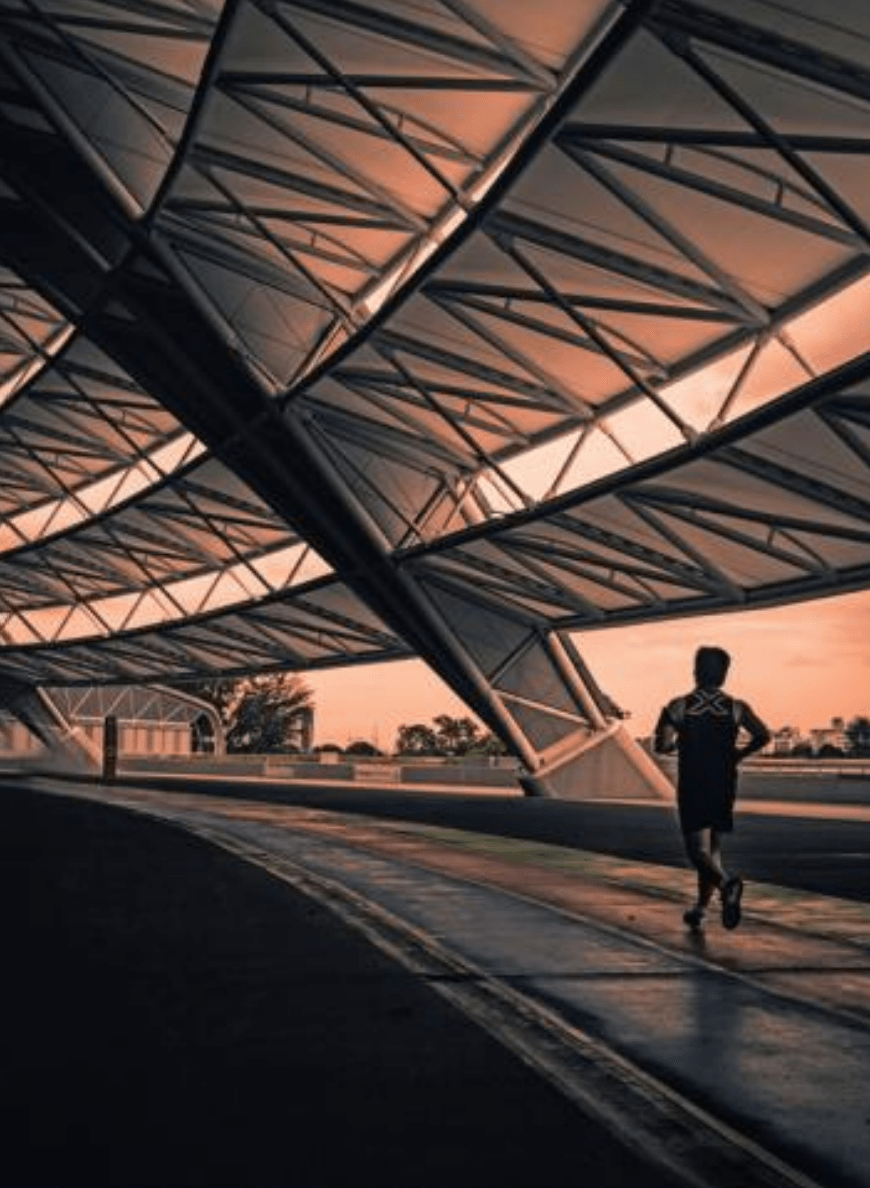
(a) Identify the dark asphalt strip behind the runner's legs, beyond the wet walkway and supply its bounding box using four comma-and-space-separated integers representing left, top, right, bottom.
128, 779, 870, 903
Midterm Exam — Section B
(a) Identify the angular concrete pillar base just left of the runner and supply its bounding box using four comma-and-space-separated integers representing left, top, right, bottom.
521, 723, 675, 802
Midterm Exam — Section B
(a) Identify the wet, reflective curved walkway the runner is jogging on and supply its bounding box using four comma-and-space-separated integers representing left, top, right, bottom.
11, 789, 870, 1188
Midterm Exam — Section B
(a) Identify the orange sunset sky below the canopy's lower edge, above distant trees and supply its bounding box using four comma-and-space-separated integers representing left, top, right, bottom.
305, 592, 870, 751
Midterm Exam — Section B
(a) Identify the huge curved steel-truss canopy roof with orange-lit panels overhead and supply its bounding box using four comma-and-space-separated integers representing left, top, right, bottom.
0, 0, 870, 685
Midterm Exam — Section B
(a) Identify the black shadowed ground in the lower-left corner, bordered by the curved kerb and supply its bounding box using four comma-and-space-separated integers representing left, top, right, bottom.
0, 789, 679, 1188
